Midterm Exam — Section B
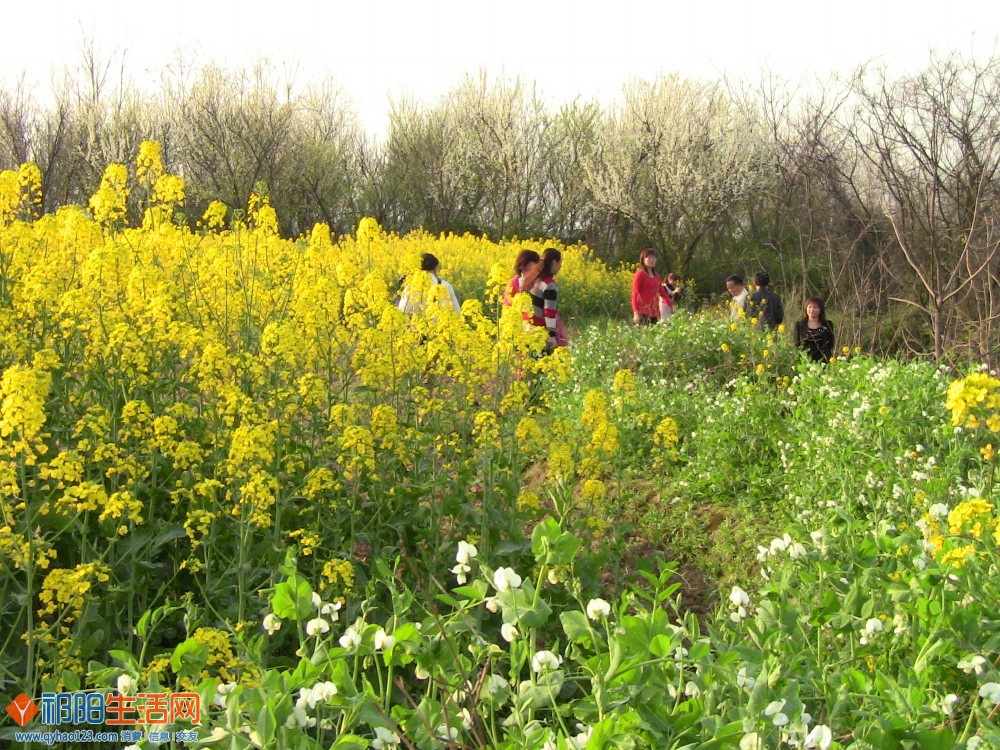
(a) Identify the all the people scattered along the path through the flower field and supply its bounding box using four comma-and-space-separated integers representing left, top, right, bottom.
399, 247, 834, 362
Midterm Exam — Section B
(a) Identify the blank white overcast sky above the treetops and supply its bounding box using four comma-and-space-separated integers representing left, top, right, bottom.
0, 0, 1000, 134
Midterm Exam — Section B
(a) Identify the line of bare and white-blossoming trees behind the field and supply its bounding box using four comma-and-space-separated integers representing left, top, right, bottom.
0, 48, 1000, 364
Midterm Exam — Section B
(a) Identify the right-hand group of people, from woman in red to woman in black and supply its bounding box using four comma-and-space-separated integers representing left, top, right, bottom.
632, 253, 834, 362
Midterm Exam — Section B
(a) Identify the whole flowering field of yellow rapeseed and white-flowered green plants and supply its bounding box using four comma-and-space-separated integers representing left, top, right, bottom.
0, 146, 1000, 750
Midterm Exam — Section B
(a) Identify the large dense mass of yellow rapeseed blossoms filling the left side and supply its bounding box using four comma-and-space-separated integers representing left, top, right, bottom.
0, 142, 634, 692
